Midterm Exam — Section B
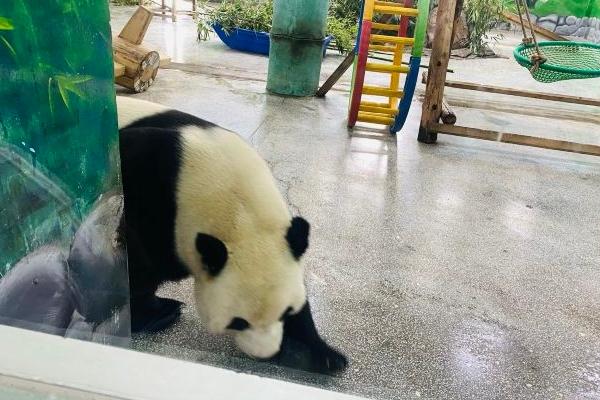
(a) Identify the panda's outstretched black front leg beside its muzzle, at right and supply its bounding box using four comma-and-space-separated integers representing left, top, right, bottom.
283, 300, 348, 374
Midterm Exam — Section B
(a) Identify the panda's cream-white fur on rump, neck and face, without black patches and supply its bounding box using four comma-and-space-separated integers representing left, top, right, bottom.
117, 96, 306, 357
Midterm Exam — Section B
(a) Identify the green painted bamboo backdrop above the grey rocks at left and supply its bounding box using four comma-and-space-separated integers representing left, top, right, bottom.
0, 0, 119, 277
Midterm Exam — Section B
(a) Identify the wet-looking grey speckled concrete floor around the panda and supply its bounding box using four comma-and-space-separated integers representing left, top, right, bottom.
112, 8, 600, 399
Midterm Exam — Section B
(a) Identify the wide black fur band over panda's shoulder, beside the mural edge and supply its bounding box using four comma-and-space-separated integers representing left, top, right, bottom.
119, 122, 189, 296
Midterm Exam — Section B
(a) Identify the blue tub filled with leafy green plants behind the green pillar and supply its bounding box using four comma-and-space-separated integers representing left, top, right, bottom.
198, 0, 358, 55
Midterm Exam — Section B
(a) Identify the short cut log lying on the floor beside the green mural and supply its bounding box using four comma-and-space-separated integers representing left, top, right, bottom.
113, 37, 160, 93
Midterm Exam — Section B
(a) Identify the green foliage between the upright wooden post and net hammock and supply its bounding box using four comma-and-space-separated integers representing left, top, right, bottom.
464, 0, 505, 55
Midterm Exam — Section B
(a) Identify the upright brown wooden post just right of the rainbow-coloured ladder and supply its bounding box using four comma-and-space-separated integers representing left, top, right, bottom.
418, 0, 457, 143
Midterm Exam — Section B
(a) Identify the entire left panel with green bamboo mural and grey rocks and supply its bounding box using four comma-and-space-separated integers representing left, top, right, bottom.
0, 0, 130, 343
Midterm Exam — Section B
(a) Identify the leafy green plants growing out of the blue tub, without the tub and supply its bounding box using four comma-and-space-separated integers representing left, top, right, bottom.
198, 0, 360, 53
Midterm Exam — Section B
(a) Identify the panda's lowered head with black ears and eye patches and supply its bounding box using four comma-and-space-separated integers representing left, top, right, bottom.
190, 217, 310, 358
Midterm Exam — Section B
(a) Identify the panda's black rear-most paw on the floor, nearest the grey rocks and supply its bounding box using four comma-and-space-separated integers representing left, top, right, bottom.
130, 293, 183, 333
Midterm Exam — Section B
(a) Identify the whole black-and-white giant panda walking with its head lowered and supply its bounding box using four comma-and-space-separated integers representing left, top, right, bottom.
117, 97, 347, 373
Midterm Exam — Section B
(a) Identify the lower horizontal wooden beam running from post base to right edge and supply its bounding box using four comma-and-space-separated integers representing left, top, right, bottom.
429, 123, 600, 156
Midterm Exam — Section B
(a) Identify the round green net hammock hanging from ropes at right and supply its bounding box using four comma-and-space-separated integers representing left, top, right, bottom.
514, 41, 600, 83
